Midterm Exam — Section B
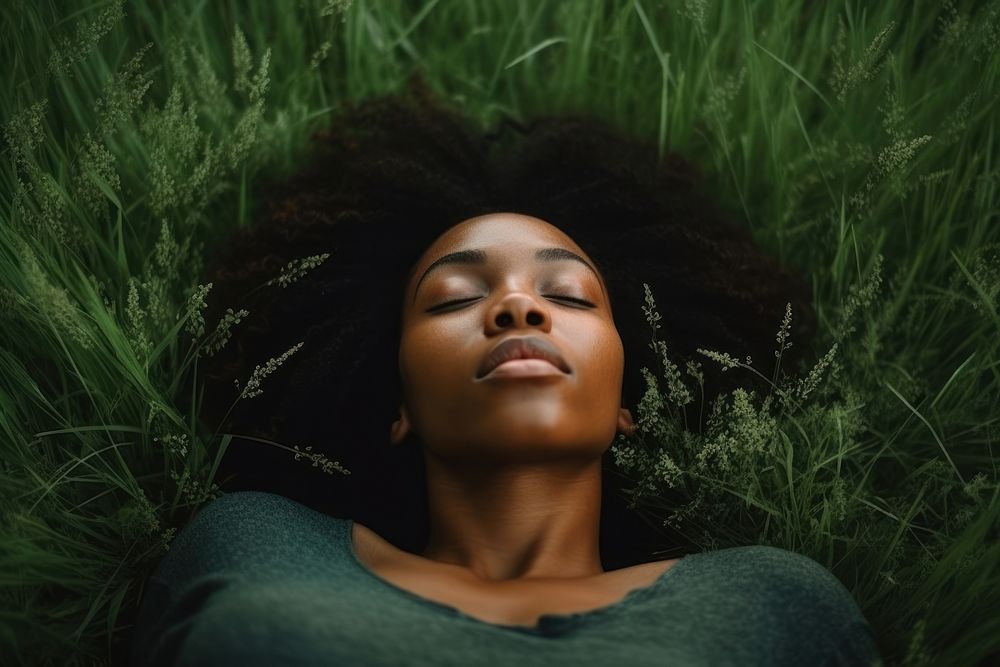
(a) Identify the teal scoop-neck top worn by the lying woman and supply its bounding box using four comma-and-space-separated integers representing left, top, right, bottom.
132, 491, 881, 667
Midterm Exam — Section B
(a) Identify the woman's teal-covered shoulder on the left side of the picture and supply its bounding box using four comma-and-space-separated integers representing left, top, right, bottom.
133, 491, 347, 664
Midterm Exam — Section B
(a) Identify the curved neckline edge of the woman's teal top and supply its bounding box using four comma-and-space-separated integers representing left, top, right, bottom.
342, 519, 697, 635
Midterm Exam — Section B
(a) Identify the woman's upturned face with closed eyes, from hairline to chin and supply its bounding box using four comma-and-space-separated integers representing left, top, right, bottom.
391, 213, 631, 463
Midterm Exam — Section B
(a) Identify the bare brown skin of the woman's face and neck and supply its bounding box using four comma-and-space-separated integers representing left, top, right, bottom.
390, 213, 634, 584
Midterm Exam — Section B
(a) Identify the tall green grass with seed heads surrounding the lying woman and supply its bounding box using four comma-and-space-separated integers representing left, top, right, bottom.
0, 0, 1000, 665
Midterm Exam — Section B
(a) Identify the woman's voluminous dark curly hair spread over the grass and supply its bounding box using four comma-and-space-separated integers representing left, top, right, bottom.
200, 79, 815, 570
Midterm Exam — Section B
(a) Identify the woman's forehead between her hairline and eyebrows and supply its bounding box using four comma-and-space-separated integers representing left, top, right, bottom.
410, 213, 590, 280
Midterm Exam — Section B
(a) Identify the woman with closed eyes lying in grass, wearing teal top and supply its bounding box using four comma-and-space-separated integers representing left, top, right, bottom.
134, 77, 878, 665
